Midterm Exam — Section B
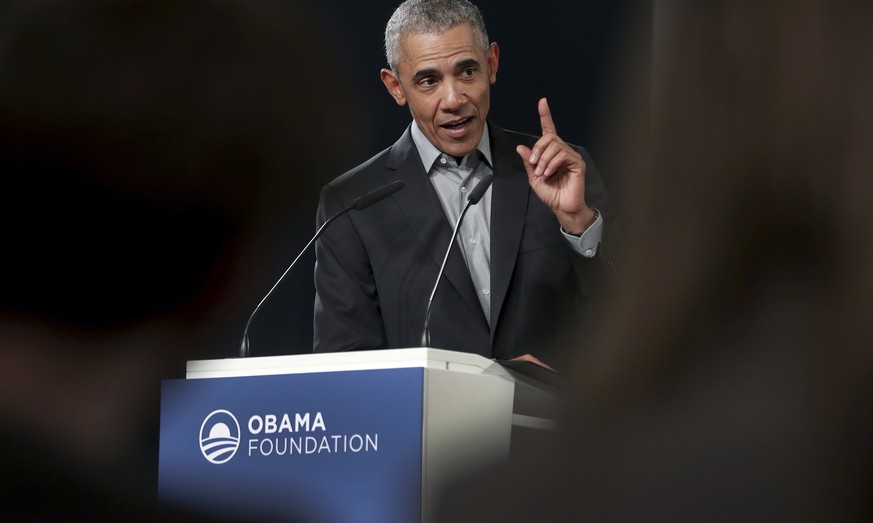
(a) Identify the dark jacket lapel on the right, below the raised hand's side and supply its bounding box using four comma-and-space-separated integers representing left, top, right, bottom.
490, 124, 530, 341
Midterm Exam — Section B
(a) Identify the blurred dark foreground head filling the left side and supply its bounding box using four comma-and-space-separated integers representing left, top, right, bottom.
0, 0, 347, 516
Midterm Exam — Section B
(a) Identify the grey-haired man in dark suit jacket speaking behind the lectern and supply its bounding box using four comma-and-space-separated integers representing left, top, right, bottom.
314, 0, 612, 367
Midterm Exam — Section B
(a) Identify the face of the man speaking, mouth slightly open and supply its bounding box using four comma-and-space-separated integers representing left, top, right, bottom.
382, 23, 499, 157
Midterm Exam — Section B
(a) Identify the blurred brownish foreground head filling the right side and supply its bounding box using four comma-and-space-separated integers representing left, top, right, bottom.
446, 0, 873, 521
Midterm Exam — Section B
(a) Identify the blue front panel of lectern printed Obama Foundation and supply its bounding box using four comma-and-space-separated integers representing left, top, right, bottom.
159, 368, 424, 523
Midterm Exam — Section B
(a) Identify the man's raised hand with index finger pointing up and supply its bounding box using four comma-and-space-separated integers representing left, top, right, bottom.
516, 98, 595, 234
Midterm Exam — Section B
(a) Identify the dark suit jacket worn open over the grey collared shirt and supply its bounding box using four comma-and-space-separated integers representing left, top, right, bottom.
314, 123, 611, 363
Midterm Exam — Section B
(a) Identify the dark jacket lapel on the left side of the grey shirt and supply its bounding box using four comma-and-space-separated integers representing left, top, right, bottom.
385, 128, 485, 322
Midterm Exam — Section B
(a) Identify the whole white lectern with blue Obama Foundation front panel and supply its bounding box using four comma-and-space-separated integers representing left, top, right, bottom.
159, 348, 558, 523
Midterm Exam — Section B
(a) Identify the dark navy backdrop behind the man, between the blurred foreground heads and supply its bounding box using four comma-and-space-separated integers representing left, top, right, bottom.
240, 0, 652, 357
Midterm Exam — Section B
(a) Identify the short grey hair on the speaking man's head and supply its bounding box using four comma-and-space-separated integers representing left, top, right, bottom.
385, 0, 490, 70
